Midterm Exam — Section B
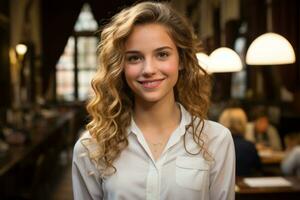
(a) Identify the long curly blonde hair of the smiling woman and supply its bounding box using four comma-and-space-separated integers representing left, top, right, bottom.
87, 2, 210, 172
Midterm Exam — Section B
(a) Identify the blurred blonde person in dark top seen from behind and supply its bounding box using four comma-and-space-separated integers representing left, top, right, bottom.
219, 108, 261, 176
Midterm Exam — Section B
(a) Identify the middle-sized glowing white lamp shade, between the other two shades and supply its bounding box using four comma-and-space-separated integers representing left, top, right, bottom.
208, 47, 243, 73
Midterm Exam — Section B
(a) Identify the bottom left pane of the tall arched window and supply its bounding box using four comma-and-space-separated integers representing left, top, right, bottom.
56, 70, 74, 101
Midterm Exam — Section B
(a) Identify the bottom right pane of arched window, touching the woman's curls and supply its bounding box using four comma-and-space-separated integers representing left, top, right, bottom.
78, 70, 95, 100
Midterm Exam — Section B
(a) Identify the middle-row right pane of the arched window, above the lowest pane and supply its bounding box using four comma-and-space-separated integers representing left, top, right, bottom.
78, 37, 98, 69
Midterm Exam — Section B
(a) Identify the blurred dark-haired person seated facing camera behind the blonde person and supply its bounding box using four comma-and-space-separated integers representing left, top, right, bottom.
245, 107, 282, 151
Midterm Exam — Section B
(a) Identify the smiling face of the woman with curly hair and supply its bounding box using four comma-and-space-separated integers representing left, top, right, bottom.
124, 24, 179, 103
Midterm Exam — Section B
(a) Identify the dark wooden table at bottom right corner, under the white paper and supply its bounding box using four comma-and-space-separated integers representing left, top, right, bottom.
236, 177, 300, 200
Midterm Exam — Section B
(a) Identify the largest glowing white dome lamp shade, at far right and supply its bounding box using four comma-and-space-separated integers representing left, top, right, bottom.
246, 33, 296, 65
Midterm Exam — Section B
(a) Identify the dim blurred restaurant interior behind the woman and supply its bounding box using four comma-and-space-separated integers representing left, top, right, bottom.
0, 0, 300, 200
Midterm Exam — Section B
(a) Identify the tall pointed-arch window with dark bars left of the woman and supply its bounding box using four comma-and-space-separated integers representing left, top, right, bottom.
56, 4, 98, 101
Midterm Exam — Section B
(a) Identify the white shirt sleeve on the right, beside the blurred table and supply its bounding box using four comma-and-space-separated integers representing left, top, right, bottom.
209, 128, 235, 200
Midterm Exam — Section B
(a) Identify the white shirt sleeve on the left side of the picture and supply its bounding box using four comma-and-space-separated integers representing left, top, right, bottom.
72, 140, 103, 200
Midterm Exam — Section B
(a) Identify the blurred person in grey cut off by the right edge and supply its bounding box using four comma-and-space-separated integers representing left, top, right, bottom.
281, 133, 300, 177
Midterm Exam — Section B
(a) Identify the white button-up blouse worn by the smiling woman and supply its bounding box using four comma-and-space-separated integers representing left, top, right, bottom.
72, 105, 235, 200
